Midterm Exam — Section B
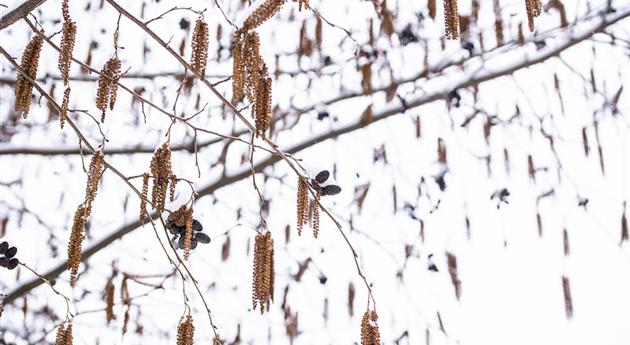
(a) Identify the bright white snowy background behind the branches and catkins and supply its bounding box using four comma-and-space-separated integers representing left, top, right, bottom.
0, 0, 630, 345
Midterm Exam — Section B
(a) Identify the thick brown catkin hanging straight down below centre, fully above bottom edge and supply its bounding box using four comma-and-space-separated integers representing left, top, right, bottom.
252, 230, 275, 314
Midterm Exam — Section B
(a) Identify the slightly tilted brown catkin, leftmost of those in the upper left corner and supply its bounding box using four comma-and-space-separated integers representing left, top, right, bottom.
15, 34, 44, 119
